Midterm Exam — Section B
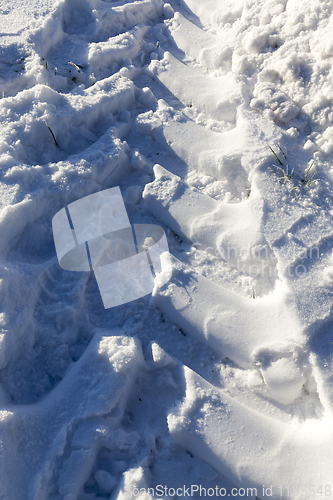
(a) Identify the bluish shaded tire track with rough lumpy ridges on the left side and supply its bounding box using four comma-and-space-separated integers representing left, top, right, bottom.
1, 1, 235, 500
